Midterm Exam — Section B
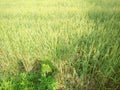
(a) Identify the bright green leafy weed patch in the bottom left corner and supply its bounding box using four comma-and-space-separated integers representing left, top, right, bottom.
0, 60, 57, 90
